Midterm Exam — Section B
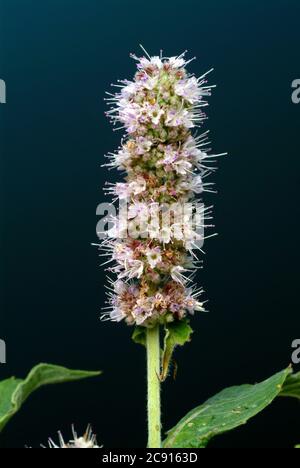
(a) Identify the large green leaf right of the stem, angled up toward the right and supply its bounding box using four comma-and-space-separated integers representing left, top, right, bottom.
164, 368, 292, 448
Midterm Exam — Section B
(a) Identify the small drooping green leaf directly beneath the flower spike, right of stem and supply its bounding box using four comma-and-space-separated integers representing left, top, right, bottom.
160, 319, 193, 382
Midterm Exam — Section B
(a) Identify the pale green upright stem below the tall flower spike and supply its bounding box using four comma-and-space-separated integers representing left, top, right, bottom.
147, 325, 161, 448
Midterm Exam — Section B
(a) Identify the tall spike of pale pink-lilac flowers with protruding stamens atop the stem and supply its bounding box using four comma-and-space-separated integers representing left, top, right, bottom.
101, 47, 219, 327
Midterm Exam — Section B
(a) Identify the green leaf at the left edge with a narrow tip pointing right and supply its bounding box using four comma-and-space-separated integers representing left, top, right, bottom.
0, 364, 101, 432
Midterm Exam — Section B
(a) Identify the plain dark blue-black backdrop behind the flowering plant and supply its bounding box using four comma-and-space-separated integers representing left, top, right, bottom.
0, 0, 300, 448
